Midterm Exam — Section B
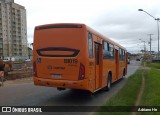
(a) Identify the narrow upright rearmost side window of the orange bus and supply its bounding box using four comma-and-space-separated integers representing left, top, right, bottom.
88, 32, 93, 58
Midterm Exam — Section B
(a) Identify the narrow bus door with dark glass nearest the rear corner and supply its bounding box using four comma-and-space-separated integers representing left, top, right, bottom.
94, 43, 100, 89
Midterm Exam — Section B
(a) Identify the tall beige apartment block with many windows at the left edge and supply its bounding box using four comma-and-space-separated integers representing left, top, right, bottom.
0, 0, 28, 59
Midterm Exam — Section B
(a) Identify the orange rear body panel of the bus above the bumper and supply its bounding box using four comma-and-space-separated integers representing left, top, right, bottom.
34, 24, 86, 80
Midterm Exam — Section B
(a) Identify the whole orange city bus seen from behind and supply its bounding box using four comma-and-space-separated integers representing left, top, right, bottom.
33, 23, 127, 93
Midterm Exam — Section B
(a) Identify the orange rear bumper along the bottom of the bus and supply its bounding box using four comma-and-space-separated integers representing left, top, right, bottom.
33, 77, 89, 90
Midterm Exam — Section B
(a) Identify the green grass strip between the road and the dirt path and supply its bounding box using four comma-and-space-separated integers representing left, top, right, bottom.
99, 70, 142, 115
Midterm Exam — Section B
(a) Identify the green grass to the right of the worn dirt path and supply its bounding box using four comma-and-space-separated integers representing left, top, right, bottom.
141, 69, 160, 106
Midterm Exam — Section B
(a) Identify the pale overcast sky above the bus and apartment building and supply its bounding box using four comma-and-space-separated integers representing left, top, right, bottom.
15, 0, 160, 53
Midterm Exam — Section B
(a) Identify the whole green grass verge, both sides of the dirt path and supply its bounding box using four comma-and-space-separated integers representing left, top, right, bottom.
98, 63, 160, 115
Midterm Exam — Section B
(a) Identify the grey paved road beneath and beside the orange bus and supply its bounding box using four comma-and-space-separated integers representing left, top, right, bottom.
0, 61, 140, 114
